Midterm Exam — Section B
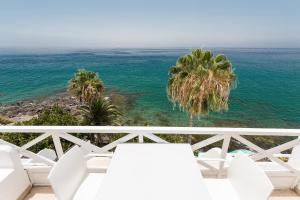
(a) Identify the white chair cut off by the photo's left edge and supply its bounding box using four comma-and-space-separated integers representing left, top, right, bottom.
0, 145, 31, 200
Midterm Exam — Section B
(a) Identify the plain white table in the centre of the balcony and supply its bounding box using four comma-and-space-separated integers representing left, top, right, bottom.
96, 144, 210, 200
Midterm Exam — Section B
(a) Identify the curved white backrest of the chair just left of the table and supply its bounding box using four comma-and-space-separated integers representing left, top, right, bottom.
48, 146, 87, 200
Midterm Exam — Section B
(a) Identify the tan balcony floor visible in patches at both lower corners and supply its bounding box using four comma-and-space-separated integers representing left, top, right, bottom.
24, 187, 300, 200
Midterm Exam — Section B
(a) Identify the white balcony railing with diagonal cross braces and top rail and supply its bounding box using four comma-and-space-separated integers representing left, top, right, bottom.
0, 126, 300, 186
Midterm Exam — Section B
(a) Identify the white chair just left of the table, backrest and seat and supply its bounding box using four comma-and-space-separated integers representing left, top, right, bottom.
48, 146, 104, 200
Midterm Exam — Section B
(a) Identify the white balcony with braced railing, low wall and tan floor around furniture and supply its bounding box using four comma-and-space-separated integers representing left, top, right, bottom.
0, 126, 300, 200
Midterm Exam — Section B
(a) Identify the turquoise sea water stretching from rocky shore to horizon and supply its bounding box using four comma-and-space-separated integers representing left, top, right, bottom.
0, 49, 300, 128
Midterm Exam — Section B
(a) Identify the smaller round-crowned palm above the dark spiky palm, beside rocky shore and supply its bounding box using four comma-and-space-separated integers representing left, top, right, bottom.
68, 69, 104, 103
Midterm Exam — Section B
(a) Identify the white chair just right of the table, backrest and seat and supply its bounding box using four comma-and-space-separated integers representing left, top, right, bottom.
205, 155, 273, 200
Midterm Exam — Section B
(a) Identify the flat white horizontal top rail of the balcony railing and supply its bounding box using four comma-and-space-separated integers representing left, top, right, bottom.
0, 126, 300, 136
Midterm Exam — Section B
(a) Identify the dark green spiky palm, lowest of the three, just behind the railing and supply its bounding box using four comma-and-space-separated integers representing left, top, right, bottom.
82, 97, 122, 145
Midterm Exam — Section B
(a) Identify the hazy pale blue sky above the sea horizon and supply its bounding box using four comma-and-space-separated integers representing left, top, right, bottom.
0, 0, 300, 48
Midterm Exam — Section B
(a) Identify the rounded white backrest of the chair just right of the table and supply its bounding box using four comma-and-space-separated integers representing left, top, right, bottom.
228, 155, 273, 200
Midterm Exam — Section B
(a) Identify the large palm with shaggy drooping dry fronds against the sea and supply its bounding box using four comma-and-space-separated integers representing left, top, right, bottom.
167, 49, 236, 126
